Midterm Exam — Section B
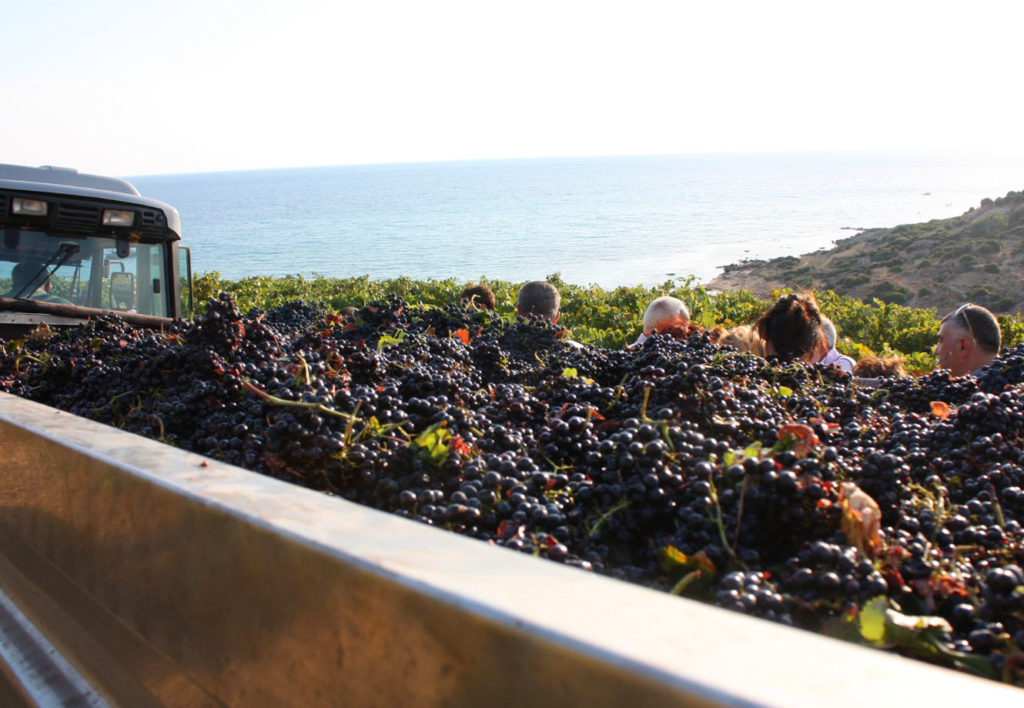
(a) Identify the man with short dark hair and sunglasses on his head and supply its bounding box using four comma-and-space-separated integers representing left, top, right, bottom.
935, 302, 1002, 376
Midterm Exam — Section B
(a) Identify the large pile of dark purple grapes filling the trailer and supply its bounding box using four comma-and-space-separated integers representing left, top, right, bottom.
0, 295, 1024, 685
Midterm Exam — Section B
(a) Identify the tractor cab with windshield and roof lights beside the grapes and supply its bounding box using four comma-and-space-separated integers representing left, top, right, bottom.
0, 165, 193, 336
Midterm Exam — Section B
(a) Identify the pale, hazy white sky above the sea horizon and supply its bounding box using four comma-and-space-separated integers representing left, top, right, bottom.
8, 0, 1024, 175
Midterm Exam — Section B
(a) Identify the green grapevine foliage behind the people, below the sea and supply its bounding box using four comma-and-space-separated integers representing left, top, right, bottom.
195, 273, 1024, 371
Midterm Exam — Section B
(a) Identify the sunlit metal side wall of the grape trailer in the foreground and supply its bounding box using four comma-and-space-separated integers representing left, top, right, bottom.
0, 393, 1024, 708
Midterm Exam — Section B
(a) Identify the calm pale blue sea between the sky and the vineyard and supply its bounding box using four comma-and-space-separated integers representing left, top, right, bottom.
128, 152, 1024, 288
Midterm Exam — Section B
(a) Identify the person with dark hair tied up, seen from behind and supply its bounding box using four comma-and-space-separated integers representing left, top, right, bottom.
754, 293, 828, 364
